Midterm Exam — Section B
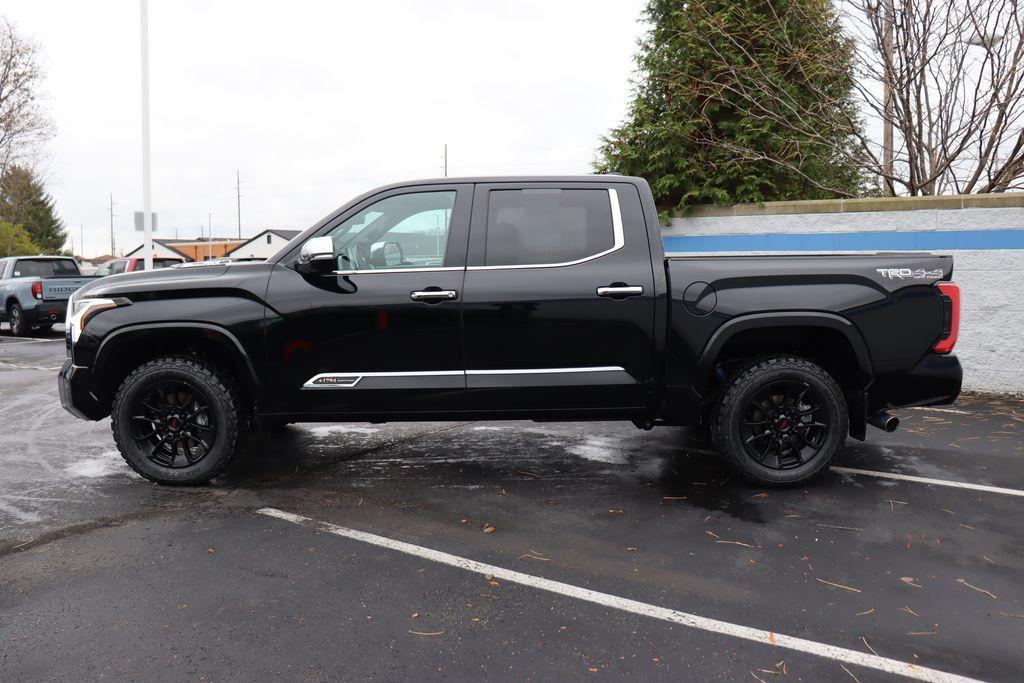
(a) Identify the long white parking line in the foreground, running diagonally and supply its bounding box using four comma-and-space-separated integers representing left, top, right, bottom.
256, 508, 975, 683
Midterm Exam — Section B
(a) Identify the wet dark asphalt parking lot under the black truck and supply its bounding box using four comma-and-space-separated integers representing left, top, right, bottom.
0, 326, 1024, 681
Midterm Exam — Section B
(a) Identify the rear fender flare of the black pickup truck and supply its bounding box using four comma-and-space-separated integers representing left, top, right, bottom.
696, 311, 873, 391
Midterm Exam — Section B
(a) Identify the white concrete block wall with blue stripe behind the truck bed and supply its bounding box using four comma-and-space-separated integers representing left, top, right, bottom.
664, 195, 1024, 395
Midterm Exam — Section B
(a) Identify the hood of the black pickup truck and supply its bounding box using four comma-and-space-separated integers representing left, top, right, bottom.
75, 262, 273, 299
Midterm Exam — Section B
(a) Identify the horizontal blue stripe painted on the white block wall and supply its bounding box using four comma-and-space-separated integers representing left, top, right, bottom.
663, 229, 1024, 253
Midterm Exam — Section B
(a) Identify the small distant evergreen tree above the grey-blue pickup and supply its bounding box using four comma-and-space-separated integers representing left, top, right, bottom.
0, 166, 68, 254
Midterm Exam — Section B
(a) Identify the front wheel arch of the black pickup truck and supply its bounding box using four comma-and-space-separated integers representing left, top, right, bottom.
92, 323, 259, 408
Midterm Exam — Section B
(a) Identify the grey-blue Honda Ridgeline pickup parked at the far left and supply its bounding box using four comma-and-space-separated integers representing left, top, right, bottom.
0, 256, 92, 337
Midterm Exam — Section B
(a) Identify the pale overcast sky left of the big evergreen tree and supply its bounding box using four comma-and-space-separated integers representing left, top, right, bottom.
0, 0, 645, 256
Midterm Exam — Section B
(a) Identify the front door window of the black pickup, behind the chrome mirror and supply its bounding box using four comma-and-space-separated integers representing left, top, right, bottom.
328, 191, 456, 270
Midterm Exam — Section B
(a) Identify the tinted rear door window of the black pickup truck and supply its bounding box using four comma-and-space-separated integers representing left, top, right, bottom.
484, 188, 615, 266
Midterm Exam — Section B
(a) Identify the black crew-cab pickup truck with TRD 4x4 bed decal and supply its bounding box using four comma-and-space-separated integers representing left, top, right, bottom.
58, 176, 962, 484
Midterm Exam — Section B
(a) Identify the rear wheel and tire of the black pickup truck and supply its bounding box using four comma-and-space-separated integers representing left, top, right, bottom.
711, 356, 850, 486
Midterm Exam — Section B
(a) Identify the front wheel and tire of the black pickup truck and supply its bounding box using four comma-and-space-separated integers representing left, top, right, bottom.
111, 356, 243, 485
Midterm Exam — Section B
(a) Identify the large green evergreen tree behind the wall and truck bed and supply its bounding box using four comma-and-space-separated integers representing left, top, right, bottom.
596, 0, 865, 211
